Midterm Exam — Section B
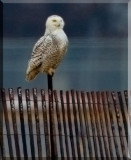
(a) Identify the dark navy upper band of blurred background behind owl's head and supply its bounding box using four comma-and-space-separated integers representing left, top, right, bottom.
3, 3, 128, 38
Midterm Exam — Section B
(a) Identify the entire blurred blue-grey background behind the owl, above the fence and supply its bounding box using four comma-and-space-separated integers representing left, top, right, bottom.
3, 3, 128, 90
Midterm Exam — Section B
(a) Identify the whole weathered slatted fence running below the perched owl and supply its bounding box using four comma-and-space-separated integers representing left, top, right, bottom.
0, 88, 131, 160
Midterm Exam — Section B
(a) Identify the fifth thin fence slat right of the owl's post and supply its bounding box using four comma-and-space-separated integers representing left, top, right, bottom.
76, 91, 88, 160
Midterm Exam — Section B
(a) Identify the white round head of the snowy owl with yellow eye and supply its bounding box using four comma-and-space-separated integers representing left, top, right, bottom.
46, 15, 65, 31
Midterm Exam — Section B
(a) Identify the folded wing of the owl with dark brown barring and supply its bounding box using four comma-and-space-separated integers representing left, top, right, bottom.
26, 34, 58, 81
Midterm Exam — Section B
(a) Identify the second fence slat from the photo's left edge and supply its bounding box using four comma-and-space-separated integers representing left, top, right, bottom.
9, 88, 21, 160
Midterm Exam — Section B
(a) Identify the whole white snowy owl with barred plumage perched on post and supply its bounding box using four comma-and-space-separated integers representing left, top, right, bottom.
26, 15, 68, 81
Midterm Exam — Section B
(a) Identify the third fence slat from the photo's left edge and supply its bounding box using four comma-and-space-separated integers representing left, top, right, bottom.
17, 87, 28, 160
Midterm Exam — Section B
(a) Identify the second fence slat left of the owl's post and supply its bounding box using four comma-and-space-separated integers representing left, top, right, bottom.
33, 88, 42, 160
